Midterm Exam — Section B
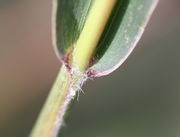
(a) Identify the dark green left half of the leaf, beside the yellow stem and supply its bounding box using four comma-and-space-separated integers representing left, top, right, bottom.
53, 0, 94, 57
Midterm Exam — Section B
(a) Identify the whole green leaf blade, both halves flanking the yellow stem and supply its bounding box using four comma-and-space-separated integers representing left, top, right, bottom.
53, 0, 158, 77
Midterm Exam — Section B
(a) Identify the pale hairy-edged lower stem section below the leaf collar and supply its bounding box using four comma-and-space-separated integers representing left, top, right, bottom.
30, 65, 75, 137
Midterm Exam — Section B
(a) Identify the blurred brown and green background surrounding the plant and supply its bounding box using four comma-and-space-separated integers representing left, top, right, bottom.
0, 0, 180, 137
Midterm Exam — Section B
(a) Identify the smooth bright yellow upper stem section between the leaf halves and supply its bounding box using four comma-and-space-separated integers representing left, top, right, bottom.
72, 0, 117, 72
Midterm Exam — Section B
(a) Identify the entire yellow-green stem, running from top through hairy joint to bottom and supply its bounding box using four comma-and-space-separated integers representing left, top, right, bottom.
30, 0, 117, 137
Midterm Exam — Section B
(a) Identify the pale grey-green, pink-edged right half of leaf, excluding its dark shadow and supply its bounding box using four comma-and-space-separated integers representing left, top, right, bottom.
90, 0, 158, 77
